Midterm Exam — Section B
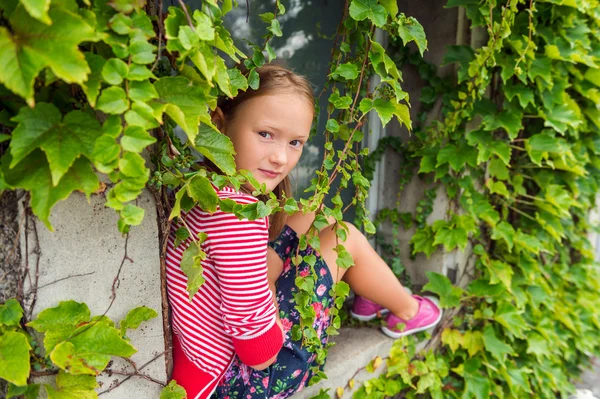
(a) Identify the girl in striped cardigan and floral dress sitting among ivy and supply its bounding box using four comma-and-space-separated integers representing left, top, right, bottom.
166, 65, 441, 399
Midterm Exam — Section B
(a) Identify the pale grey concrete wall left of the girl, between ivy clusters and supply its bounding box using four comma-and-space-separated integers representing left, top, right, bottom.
21, 191, 167, 399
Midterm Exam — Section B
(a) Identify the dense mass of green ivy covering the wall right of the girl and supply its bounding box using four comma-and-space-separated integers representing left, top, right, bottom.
354, 0, 600, 399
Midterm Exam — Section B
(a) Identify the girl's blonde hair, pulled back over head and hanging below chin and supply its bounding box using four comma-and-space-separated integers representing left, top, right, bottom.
217, 64, 315, 239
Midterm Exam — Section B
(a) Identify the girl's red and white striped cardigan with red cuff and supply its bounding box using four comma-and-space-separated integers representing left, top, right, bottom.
166, 187, 283, 397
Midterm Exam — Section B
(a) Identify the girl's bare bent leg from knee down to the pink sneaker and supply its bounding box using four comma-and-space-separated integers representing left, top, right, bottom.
287, 213, 419, 320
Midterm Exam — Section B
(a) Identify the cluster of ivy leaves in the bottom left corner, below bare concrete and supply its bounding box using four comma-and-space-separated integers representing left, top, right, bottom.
0, 299, 157, 399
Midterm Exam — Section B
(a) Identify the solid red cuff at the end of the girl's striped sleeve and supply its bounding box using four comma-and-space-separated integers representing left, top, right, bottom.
231, 323, 283, 366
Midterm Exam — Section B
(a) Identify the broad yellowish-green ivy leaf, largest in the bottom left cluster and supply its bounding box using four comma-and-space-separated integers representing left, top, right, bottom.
50, 323, 136, 376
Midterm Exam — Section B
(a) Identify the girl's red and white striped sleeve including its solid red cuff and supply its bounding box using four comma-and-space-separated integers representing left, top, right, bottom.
206, 202, 283, 366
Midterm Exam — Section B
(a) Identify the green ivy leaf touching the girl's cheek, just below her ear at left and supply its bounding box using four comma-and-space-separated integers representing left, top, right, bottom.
194, 123, 236, 176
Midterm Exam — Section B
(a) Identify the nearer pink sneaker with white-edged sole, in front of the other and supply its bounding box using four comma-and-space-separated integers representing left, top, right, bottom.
381, 295, 442, 338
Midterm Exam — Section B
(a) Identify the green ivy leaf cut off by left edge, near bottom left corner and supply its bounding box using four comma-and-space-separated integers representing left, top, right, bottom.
0, 331, 31, 385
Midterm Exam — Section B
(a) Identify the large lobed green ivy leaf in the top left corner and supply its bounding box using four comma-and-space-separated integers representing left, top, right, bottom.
0, 6, 98, 106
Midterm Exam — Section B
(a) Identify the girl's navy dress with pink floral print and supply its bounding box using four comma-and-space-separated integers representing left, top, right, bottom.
211, 226, 333, 399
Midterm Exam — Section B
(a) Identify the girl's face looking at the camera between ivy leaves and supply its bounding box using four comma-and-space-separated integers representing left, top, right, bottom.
217, 93, 313, 191
